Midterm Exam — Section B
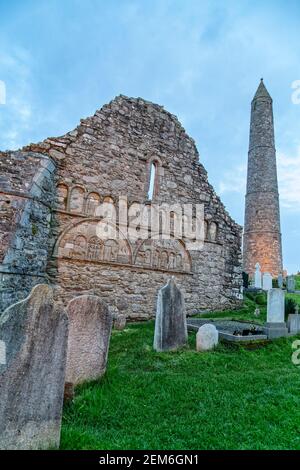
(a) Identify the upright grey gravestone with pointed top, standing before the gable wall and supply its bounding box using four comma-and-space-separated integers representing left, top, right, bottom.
153, 277, 187, 351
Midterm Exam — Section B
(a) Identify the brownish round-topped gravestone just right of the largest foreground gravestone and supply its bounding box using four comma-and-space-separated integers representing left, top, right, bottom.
66, 295, 112, 385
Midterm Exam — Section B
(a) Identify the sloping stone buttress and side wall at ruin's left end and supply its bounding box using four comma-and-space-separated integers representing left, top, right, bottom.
0, 152, 56, 311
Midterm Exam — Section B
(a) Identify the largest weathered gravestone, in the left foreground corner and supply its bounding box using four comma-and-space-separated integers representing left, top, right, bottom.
0, 284, 68, 450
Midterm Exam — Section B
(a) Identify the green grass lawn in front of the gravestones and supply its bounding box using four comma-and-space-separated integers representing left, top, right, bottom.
61, 296, 300, 449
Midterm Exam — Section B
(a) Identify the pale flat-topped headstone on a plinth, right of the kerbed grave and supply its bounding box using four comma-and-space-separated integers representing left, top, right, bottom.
264, 289, 288, 339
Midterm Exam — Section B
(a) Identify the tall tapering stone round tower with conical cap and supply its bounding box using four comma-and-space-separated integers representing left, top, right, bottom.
243, 79, 282, 277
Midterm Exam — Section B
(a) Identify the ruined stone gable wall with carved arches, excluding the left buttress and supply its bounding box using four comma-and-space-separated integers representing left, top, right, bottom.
0, 96, 242, 319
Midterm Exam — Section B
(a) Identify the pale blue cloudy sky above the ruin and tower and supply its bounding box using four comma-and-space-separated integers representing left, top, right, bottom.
0, 0, 300, 272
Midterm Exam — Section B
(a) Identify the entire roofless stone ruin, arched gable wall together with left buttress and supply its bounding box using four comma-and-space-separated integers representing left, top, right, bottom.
1, 96, 242, 319
